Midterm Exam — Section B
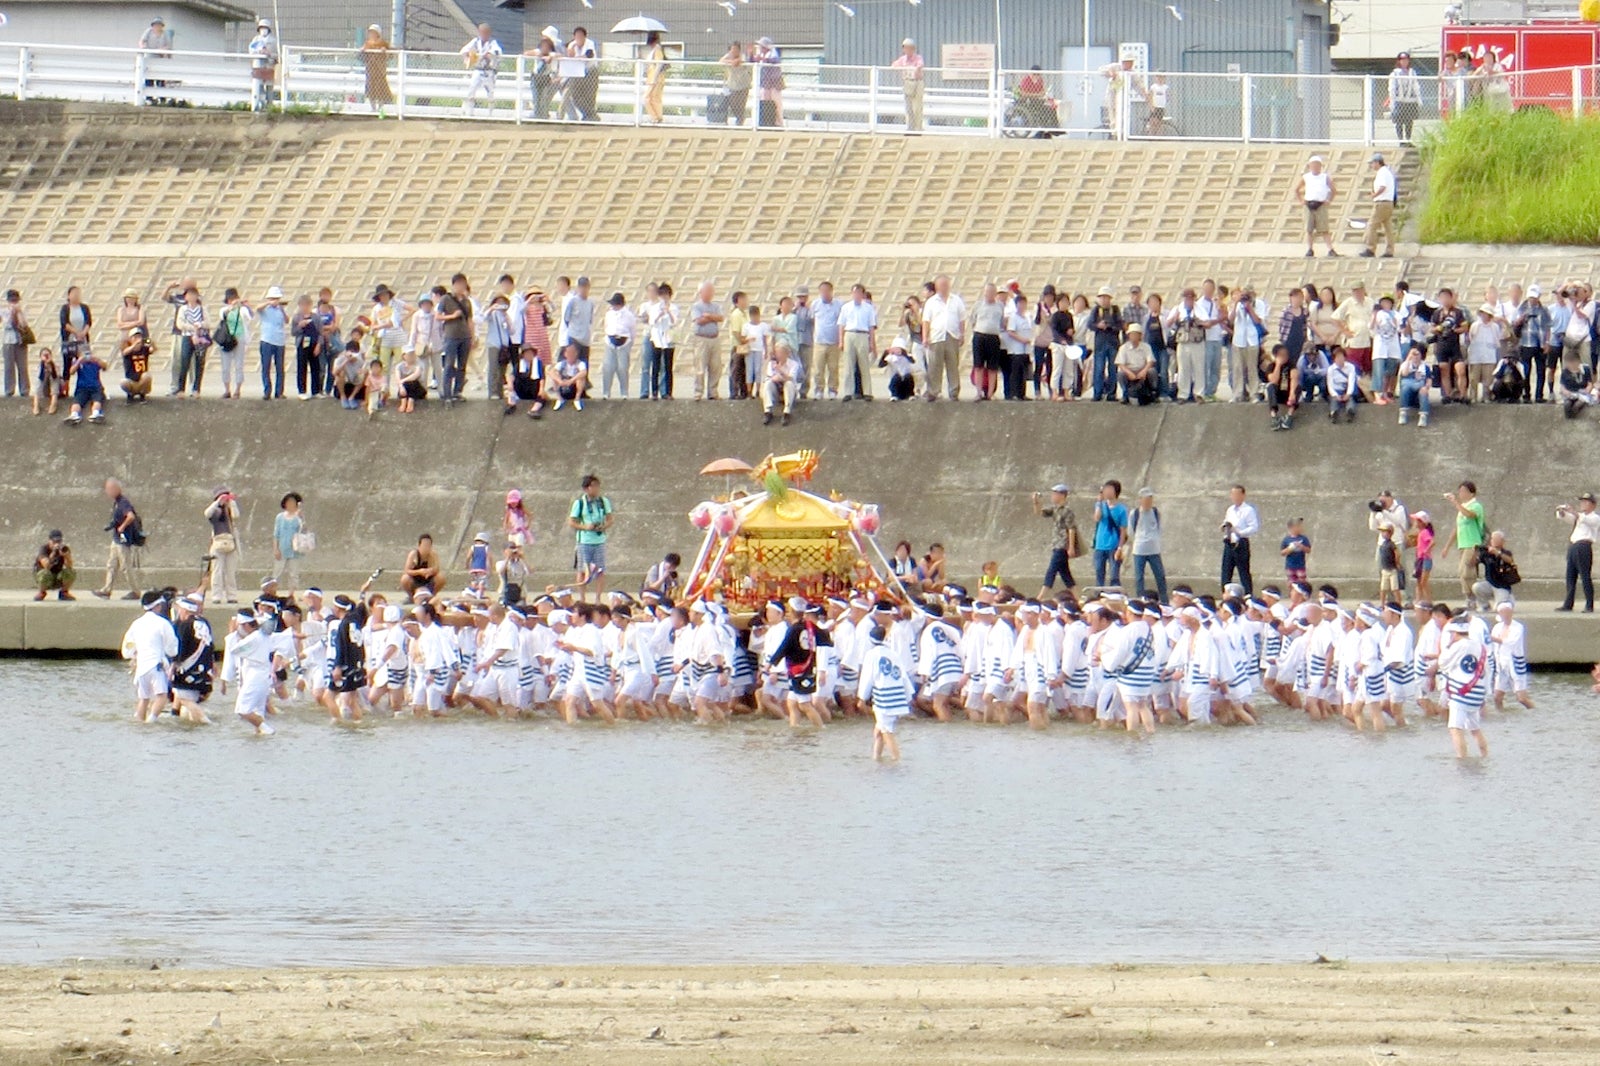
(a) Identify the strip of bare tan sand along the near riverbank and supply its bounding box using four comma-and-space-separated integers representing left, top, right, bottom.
0, 960, 1600, 1066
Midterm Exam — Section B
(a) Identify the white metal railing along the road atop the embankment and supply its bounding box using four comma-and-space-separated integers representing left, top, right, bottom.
0, 43, 1600, 144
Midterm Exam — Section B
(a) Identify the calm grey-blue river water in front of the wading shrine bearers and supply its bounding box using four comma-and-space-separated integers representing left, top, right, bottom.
0, 659, 1600, 965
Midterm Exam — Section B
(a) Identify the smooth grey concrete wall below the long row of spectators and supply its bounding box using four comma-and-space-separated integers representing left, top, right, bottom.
0, 400, 1600, 594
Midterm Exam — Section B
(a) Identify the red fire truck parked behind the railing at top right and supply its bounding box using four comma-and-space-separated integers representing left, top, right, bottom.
1440, 0, 1600, 112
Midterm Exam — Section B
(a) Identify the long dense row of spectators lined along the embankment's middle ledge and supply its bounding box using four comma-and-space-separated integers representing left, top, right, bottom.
0, 274, 1600, 429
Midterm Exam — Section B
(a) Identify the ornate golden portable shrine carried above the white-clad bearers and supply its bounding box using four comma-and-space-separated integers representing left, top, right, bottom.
685, 451, 907, 615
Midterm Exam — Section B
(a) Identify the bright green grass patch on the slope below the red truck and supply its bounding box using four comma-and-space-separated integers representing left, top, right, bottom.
1421, 107, 1600, 246
